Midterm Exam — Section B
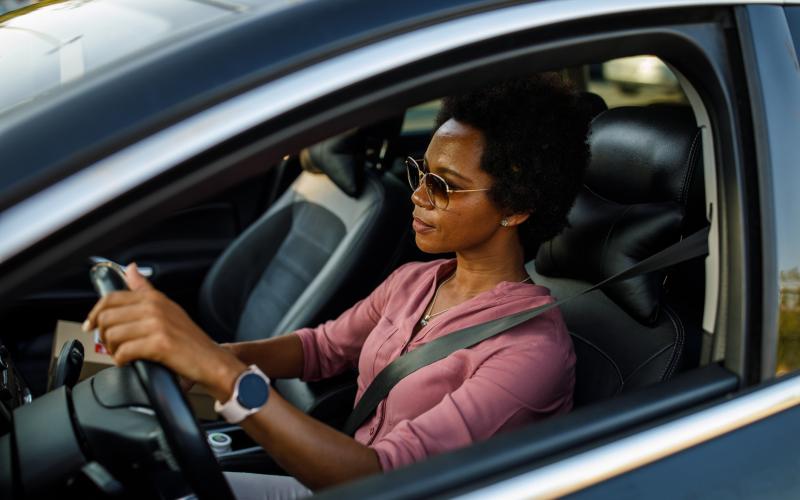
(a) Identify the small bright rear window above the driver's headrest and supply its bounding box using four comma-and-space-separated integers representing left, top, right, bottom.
586, 55, 688, 108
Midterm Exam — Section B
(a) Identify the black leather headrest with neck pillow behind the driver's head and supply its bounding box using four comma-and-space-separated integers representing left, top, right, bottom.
536, 106, 704, 324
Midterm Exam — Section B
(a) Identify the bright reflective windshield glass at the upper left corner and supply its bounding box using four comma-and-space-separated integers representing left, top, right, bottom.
0, 0, 240, 114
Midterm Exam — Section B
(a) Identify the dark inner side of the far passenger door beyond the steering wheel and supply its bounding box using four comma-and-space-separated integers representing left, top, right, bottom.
0, 156, 299, 396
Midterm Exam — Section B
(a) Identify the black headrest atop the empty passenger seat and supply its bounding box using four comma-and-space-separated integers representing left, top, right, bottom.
300, 115, 403, 197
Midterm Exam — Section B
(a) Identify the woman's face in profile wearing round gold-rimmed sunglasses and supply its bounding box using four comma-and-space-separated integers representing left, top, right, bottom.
411, 119, 503, 253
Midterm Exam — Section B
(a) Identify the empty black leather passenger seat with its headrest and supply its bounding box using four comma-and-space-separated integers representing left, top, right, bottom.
200, 116, 411, 416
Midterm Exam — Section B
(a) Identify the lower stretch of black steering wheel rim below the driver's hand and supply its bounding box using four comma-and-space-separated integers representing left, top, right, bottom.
133, 360, 235, 500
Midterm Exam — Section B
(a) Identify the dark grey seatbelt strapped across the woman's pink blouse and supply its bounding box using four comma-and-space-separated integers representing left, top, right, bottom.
344, 227, 709, 435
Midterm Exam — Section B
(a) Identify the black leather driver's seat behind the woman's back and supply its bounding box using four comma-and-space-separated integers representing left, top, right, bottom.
529, 106, 707, 406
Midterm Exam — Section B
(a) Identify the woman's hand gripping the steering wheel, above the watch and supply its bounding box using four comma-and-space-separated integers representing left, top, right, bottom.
83, 264, 246, 401
